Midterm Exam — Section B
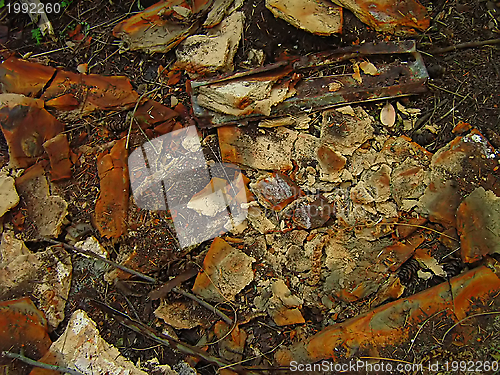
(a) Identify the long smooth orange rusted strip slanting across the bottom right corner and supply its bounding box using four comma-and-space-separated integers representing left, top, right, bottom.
275, 266, 500, 365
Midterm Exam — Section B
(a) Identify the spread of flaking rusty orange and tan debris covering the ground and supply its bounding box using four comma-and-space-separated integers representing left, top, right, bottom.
0, 0, 500, 374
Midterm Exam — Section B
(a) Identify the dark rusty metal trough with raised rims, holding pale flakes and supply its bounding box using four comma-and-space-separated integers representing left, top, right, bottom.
191, 41, 428, 128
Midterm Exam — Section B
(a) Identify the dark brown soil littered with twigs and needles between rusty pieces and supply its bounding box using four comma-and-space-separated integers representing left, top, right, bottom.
0, 0, 500, 374
